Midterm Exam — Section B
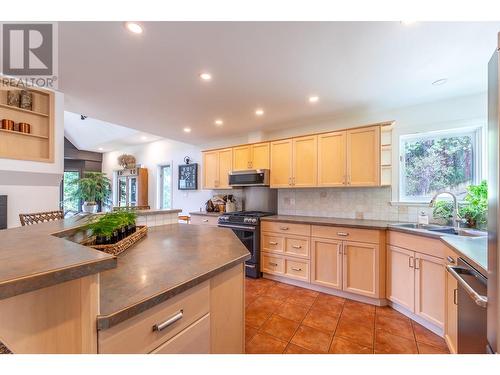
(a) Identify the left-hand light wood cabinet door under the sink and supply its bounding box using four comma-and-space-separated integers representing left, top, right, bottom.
387, 246, 415, 311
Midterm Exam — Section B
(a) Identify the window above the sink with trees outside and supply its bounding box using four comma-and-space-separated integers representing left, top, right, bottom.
399, 128, 481, 201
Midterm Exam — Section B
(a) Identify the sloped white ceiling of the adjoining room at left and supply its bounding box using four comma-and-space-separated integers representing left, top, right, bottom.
64, 111, 161, 152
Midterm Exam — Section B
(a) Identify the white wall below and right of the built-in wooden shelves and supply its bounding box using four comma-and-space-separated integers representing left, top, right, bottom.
0, 92, 64, 228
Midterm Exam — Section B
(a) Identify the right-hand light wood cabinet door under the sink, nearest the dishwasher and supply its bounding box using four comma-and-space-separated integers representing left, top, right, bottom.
415, 253, 446, 328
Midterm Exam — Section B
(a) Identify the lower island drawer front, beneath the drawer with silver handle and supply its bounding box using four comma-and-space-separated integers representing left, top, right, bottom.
151, 314, 210, 354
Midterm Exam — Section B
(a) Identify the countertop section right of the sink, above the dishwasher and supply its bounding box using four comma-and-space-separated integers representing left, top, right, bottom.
441, 236, 488, 276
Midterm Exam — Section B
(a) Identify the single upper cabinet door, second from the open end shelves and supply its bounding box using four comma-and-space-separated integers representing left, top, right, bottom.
318, 131, 347, 186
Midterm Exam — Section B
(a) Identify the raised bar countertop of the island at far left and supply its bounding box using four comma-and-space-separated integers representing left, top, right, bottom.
0, 217, 116, 299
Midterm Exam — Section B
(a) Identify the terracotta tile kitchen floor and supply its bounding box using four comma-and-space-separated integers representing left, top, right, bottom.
245, 278, 448, 354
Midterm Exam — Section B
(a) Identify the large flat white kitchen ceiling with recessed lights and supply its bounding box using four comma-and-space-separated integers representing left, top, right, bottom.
59, 22, 500, 143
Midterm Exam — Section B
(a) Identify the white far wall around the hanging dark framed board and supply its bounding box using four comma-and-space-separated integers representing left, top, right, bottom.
102, 139, 212, 213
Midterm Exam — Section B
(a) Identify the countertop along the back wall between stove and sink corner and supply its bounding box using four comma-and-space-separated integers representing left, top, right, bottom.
261, 215, 395, 230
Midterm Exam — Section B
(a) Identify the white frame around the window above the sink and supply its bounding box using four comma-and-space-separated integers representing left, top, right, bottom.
398, 125, 485, 204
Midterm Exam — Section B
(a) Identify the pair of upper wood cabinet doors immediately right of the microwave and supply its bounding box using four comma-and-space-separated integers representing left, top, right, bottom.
271, 135, 318, 188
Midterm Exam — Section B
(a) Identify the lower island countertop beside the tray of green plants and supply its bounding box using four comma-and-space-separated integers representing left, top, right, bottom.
97, 224, 250, 329
